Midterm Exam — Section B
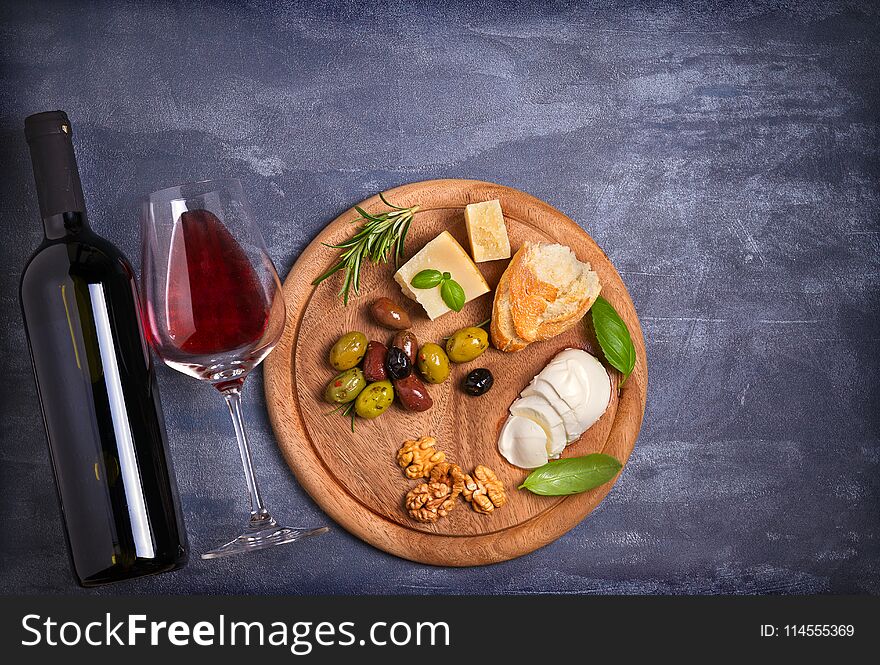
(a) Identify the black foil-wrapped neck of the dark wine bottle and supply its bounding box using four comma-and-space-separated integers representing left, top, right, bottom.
25, 111, 88, 239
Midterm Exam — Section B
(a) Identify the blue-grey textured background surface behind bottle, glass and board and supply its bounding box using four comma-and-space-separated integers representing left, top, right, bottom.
0, 0, 880, 593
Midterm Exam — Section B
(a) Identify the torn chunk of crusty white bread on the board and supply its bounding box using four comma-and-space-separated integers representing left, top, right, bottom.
491, 242, 601, 351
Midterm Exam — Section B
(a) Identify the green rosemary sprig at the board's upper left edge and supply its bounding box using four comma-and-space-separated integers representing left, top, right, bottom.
312, 192, 419, 305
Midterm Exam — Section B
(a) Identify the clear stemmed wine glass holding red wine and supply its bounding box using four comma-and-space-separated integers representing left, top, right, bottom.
142, 178, 327, 559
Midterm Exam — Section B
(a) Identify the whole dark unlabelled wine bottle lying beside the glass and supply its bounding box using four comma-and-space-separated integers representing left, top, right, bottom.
20, 111, 188, 586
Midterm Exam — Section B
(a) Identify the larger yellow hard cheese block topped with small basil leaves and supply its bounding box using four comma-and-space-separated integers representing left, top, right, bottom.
394, 231, 489, 320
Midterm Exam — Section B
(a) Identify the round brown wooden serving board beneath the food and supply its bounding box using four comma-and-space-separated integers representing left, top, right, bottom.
265, 180, 647, 566
